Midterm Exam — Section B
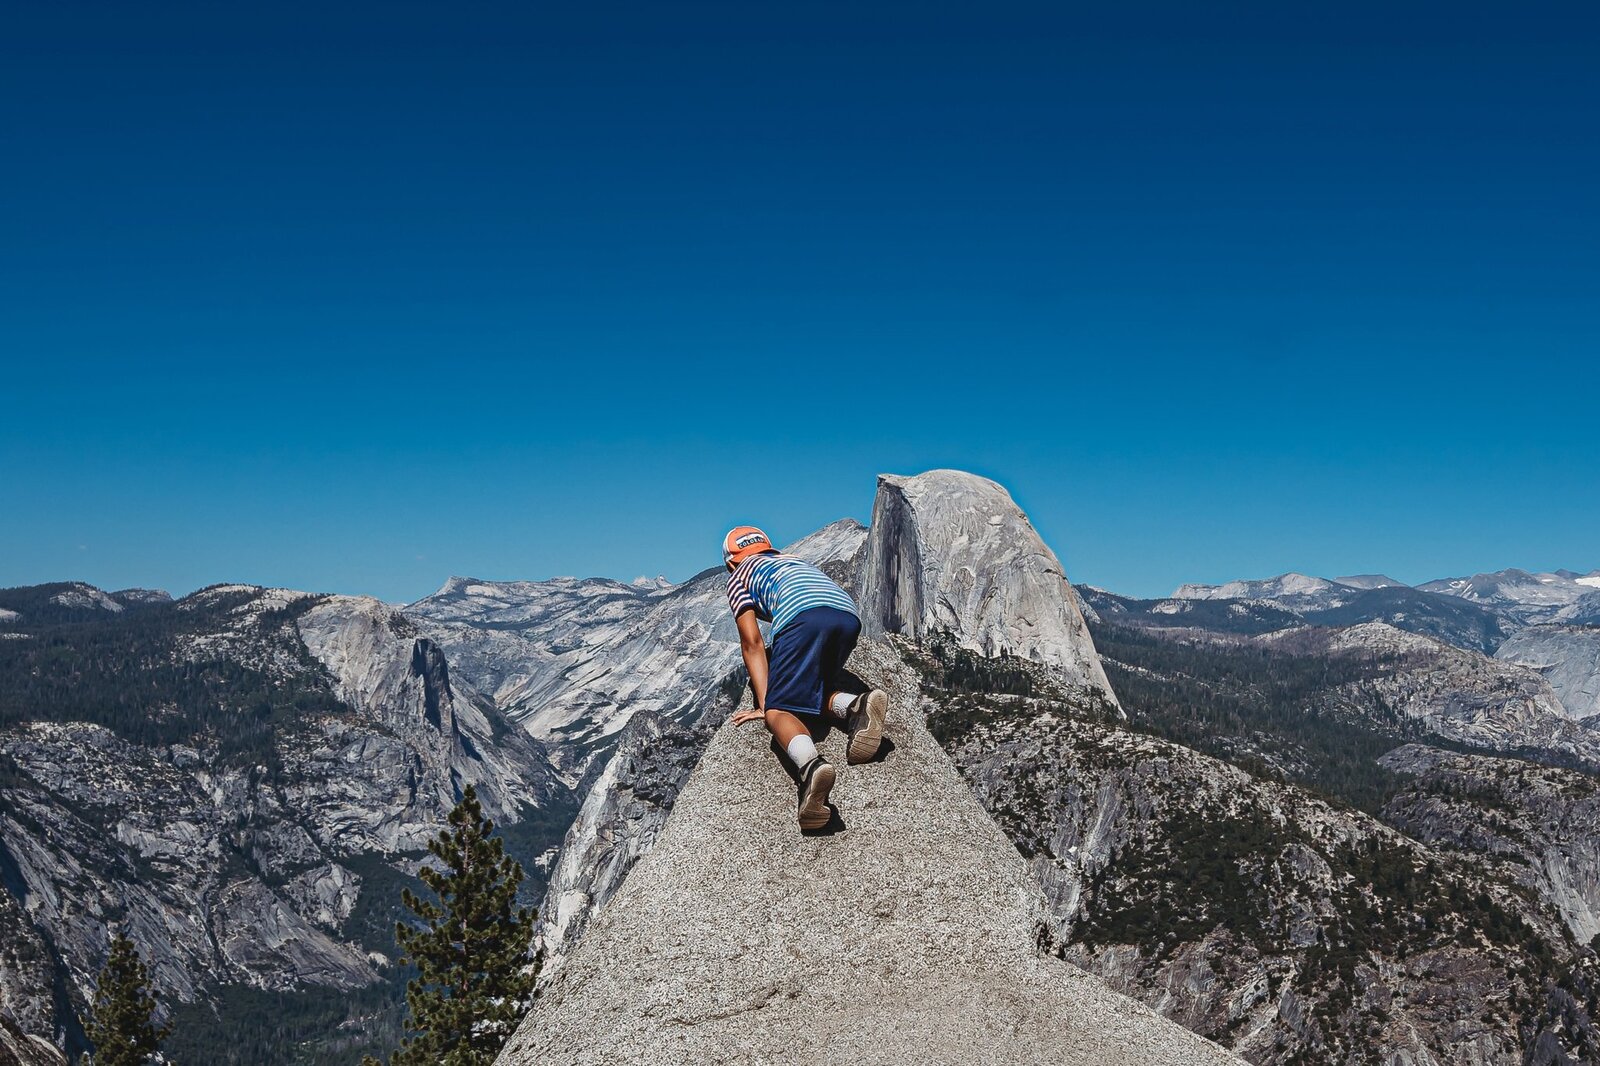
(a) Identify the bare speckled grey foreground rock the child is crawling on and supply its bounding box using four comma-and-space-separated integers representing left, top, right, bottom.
499, 642, 1237, 1066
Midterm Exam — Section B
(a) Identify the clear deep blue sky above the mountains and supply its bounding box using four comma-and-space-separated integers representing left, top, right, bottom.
0, 2, 1600, 600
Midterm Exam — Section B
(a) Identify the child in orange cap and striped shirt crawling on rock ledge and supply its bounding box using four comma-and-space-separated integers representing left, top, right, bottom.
722, 525, 890, 829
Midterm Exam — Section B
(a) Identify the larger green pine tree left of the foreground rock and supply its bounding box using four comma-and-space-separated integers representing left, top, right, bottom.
368, 786, 538, 1066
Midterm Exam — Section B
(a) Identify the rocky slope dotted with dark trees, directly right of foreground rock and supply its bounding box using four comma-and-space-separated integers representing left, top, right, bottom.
925, 646, 1600, 1066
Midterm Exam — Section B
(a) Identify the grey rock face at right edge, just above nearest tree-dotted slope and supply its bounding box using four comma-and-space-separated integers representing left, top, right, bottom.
1382, 744, 1600, 944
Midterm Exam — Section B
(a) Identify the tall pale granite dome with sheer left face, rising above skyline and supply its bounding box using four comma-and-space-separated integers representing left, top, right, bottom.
859, 471, 1115, 703
